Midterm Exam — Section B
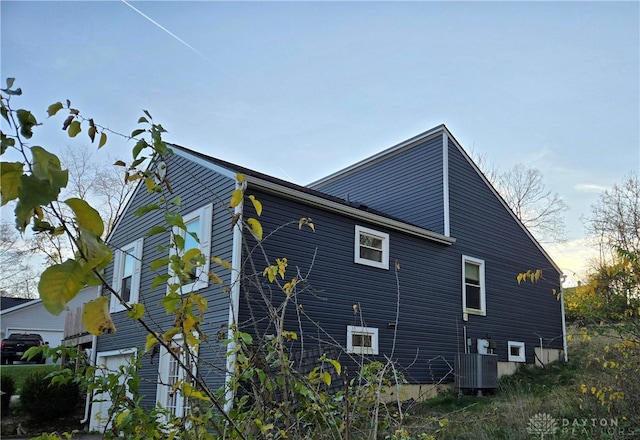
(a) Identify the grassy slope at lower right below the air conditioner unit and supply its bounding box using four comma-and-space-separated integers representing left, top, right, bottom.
407, 330, 640, 440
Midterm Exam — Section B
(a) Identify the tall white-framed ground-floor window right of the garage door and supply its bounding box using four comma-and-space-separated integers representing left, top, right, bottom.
156, 335, 197, 417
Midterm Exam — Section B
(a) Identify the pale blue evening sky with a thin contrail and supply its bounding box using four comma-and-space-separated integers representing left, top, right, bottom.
0, 0, 640, 282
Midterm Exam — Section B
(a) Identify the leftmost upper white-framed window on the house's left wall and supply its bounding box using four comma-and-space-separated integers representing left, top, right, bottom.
109, 238, 144, 313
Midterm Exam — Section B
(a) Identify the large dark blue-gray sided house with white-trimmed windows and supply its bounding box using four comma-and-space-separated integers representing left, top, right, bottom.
92, 125, 566, 427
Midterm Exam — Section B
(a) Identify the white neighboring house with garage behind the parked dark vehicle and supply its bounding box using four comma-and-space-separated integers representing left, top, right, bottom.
0, 287, 98, 354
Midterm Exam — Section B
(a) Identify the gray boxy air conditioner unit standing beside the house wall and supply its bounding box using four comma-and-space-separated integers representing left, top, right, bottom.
455, 353, 498, 390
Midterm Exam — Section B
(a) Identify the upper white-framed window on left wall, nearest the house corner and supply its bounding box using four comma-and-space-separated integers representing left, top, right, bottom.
169, 204, 213, 293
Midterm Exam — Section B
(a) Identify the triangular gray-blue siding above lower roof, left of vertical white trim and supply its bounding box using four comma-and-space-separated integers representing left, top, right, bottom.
313, 133, 444, 234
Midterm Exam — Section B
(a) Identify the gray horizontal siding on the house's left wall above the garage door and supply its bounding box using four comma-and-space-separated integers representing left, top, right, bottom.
97, 155, 234, 406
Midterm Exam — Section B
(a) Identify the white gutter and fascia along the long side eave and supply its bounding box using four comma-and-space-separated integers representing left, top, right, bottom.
246, 176, 456, 245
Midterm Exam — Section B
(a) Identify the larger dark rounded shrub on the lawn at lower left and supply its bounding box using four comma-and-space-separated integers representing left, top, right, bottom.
20, 371, 80, 419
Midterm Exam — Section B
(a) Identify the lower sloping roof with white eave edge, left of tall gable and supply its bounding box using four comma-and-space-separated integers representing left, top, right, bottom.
169, 144, 456, 244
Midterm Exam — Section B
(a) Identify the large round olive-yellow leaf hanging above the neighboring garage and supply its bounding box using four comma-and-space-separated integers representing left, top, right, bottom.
38, 260, 85, 315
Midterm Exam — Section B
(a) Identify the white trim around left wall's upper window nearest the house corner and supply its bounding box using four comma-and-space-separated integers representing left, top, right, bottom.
167, 203, 213, 293
